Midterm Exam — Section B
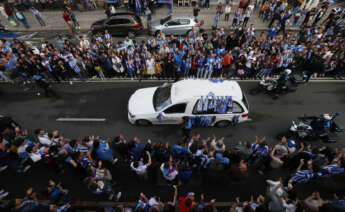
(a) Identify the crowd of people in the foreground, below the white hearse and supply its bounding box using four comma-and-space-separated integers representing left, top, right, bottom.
0, 116, 345, 212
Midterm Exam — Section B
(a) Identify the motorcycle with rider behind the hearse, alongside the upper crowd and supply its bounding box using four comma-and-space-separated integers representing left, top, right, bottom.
249, 69, 304, 99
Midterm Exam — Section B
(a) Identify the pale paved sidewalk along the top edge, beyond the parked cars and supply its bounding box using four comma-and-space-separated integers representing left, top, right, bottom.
1, 1, 299, 32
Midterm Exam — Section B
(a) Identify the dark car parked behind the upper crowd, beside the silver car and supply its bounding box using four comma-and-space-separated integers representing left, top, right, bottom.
91, 12, 144, 37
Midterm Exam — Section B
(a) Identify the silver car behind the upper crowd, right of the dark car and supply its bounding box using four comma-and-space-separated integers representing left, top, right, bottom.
149, 14, 199, 36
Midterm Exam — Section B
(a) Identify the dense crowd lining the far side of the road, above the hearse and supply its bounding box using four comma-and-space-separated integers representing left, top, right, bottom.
0, 6, 345, 93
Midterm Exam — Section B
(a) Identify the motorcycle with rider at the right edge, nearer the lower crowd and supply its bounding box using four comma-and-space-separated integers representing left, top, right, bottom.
277, 112, 345, 143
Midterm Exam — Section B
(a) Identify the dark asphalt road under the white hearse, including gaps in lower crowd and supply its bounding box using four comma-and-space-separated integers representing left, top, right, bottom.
0, 81, 345, 201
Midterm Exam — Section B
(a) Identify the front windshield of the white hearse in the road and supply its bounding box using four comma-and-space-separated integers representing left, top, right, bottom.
153, 84, 172, 111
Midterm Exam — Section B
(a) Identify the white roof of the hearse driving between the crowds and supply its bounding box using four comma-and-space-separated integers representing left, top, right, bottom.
171, 79, 243, 102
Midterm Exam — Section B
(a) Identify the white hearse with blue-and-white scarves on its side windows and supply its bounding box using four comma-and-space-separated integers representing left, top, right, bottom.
128, 79, 249, 127
